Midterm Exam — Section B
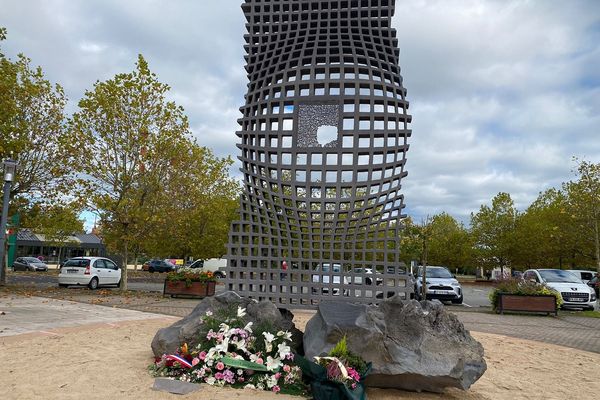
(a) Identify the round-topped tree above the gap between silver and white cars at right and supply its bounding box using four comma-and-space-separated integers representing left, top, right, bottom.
471, 193, 518, 275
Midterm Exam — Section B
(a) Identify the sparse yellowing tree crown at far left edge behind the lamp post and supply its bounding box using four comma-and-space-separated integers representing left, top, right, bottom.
0, 29, 76, 206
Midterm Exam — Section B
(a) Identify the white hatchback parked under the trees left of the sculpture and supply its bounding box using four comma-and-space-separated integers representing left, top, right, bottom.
58, 257, 121, 290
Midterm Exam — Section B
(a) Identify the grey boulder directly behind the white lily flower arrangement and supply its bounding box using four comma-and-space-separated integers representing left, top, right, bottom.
152, 292, 303, 357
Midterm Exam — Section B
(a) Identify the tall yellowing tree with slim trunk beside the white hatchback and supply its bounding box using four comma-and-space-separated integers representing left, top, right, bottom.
71, 55, 190, 290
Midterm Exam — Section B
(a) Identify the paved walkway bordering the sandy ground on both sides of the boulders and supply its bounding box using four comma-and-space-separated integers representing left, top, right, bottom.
0, 290, 600, 353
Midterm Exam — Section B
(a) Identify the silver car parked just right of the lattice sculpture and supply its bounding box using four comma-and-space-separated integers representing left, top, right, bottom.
415, 265, 463, 304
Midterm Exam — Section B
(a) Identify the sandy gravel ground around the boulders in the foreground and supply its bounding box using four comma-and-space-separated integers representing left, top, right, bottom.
0, 314, 600, 400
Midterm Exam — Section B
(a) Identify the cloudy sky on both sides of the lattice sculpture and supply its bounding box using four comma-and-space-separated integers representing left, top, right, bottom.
0, 0, 600, 230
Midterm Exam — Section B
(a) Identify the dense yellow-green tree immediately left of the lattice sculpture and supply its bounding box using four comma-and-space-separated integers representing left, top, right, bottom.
140, 143, 239, 259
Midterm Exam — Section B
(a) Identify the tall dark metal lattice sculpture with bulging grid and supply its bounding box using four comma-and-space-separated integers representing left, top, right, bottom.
226, 0, 413, 308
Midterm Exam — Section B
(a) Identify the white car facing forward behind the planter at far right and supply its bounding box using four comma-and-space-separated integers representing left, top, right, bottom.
523, 269, 596, 310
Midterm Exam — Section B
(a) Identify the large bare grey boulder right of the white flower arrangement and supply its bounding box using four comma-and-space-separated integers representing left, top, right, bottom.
304, 296, 487, 393
